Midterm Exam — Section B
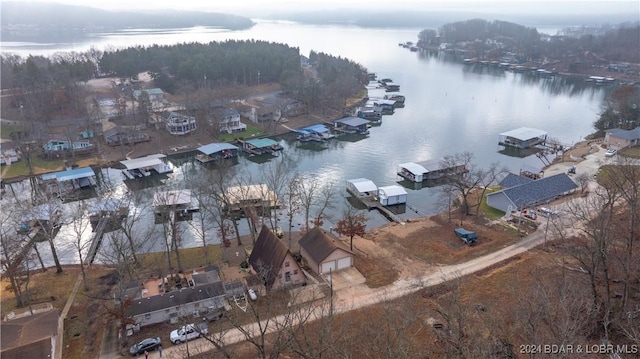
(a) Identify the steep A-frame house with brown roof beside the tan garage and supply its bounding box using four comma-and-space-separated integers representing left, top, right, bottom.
249, 225, 307, 290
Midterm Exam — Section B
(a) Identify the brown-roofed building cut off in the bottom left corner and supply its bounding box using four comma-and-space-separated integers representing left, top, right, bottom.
0, 309, 61, 359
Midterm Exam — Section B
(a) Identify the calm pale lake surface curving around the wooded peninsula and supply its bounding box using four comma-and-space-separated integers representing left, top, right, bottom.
2, 22, 610, 262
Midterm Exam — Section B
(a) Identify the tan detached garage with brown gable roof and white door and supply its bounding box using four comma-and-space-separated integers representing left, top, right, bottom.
300, 227, 353, 274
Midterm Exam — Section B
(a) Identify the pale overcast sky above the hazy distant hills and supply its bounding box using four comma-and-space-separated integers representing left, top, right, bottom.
20, 0, 640, 18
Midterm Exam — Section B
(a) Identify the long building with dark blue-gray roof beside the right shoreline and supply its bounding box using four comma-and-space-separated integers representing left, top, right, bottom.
487, 173, 578, 213
